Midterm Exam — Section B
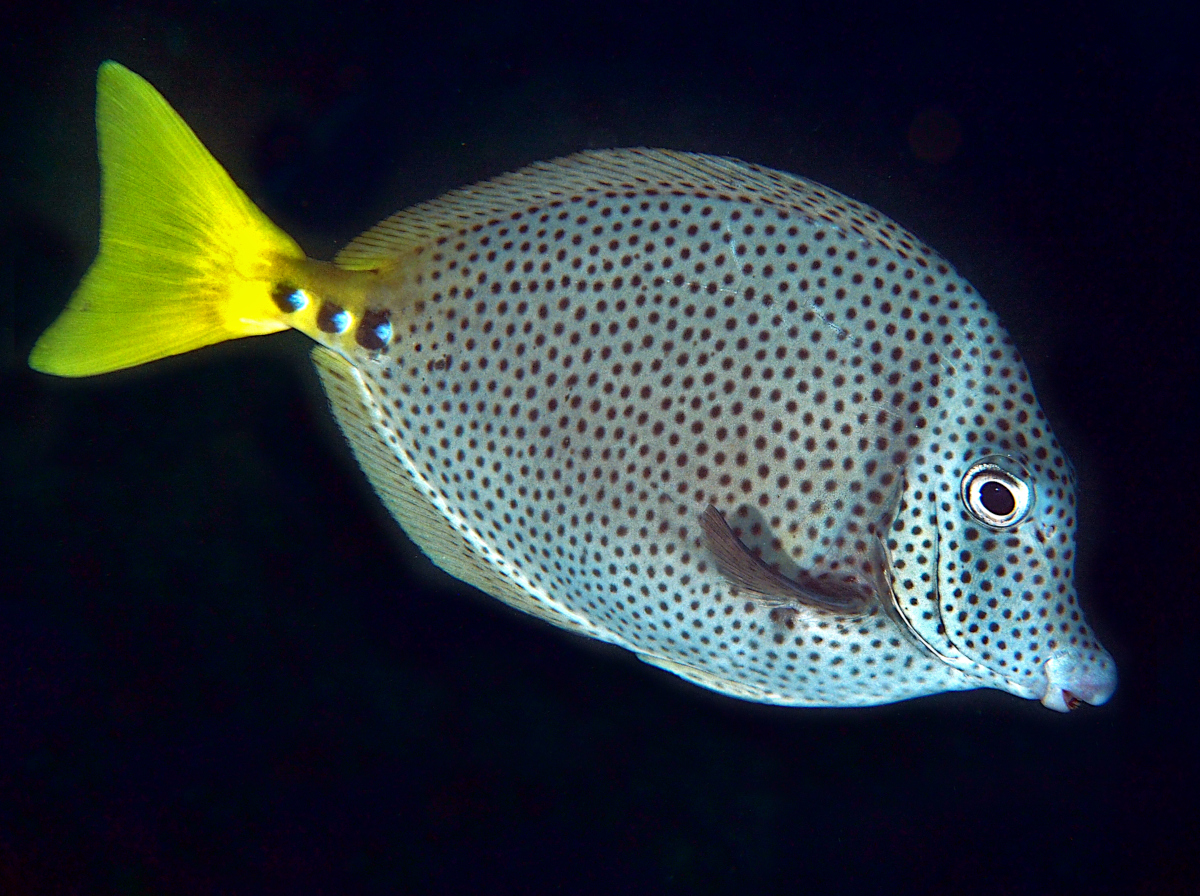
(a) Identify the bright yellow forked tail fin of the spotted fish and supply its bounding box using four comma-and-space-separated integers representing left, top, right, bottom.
29, 61, 304, 377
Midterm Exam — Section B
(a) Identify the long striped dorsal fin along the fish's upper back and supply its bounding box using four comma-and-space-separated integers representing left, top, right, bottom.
335, 149, 934, 270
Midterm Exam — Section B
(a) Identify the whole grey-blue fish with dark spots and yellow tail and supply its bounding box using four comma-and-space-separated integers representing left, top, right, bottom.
29, 61, 1117, 711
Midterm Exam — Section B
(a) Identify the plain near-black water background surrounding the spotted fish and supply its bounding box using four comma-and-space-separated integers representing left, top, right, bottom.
0, 0, 1200, 894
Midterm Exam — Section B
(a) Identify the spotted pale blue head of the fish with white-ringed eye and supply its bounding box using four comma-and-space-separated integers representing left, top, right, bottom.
886, 448, 1116, 712
